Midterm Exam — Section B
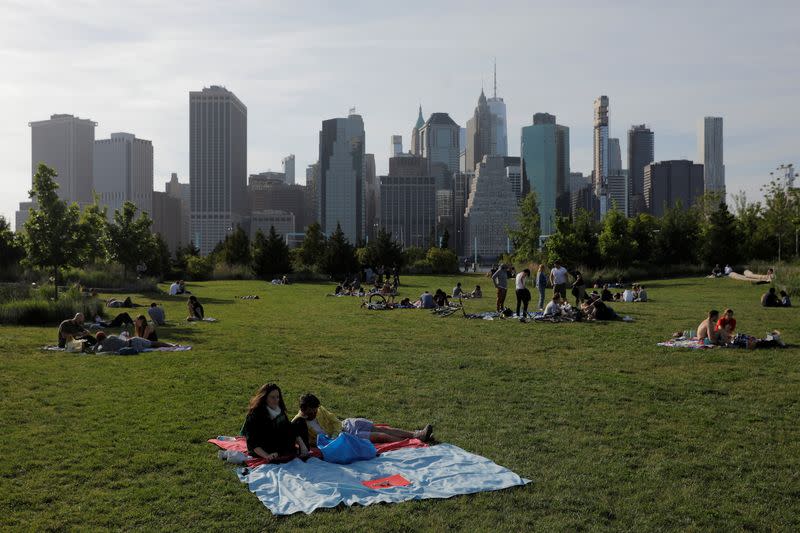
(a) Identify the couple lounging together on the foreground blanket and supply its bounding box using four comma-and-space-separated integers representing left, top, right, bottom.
241, 383, 433, 461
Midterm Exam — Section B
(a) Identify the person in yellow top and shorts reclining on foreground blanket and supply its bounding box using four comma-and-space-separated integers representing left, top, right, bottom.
292, 394, 433, 446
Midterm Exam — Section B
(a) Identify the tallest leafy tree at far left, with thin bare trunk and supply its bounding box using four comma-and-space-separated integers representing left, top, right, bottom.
24, 163, 85, 299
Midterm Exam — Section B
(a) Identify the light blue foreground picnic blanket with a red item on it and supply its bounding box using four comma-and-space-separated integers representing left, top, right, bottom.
238, 444, 530, 515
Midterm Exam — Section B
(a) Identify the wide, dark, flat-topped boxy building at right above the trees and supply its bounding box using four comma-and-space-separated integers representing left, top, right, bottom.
644, 159, 703, 217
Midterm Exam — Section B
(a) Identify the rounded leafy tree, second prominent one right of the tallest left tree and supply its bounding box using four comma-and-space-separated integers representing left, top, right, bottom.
108, 202, 154, 279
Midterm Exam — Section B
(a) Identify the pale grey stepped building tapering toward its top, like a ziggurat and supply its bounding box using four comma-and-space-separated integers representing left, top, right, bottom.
464, 156, 519, 259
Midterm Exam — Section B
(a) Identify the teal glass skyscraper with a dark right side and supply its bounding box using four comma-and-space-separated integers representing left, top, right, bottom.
520, 113, 570, 235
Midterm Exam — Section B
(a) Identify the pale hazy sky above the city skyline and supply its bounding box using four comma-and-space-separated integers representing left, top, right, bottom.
0, 0, 800, 224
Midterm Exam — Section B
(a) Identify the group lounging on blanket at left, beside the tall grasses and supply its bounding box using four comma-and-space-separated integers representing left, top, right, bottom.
58, 310, 174, 353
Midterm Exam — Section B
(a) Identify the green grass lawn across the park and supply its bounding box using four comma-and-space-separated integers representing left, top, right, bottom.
0, 276, 800, 531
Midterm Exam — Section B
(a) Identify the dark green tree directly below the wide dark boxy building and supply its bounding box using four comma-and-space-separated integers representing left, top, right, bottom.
653, 202, 700, 265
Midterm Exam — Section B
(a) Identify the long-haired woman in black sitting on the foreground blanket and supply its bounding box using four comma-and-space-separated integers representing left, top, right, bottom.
241, 383, 308, 461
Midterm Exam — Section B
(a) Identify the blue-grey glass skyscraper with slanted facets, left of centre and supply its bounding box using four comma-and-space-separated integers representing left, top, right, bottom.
316, 112, 367, 244
